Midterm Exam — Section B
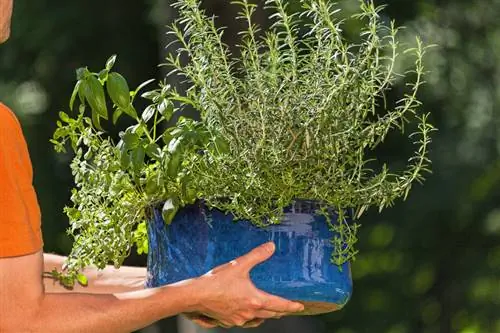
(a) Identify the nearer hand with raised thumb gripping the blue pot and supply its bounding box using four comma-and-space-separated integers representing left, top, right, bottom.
189, 243, 304, 327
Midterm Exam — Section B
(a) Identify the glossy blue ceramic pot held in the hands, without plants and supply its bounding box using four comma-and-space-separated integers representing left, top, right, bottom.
146, 201, 352, 314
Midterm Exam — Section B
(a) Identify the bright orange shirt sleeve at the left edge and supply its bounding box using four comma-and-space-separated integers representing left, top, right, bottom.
0, 103, 43, 258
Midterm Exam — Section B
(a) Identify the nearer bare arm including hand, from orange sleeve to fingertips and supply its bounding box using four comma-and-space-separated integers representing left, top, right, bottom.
0, 241, 303, 333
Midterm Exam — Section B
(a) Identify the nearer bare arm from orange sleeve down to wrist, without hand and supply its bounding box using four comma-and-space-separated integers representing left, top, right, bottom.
0, 252, 198, 333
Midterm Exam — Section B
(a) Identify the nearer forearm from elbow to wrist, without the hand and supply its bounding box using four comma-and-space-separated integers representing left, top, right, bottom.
2, 281, 196, 333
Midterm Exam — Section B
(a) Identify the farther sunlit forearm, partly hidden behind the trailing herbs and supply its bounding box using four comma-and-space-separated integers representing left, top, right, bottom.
43, 253, 146, 294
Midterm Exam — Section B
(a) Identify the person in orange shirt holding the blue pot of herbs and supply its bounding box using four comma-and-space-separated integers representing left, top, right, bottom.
0, 0, 303, 333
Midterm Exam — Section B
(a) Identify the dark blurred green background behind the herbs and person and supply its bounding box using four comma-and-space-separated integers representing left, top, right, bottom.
0, 0, 500, 333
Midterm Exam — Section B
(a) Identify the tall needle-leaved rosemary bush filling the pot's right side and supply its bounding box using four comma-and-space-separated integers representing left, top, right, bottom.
168, 0, 434, 264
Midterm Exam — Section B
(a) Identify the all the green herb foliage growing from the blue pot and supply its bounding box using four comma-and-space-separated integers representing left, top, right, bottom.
54, 0, 434, 288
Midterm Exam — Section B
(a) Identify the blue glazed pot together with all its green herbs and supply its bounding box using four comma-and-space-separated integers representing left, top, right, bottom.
53, 0, 433, 313
